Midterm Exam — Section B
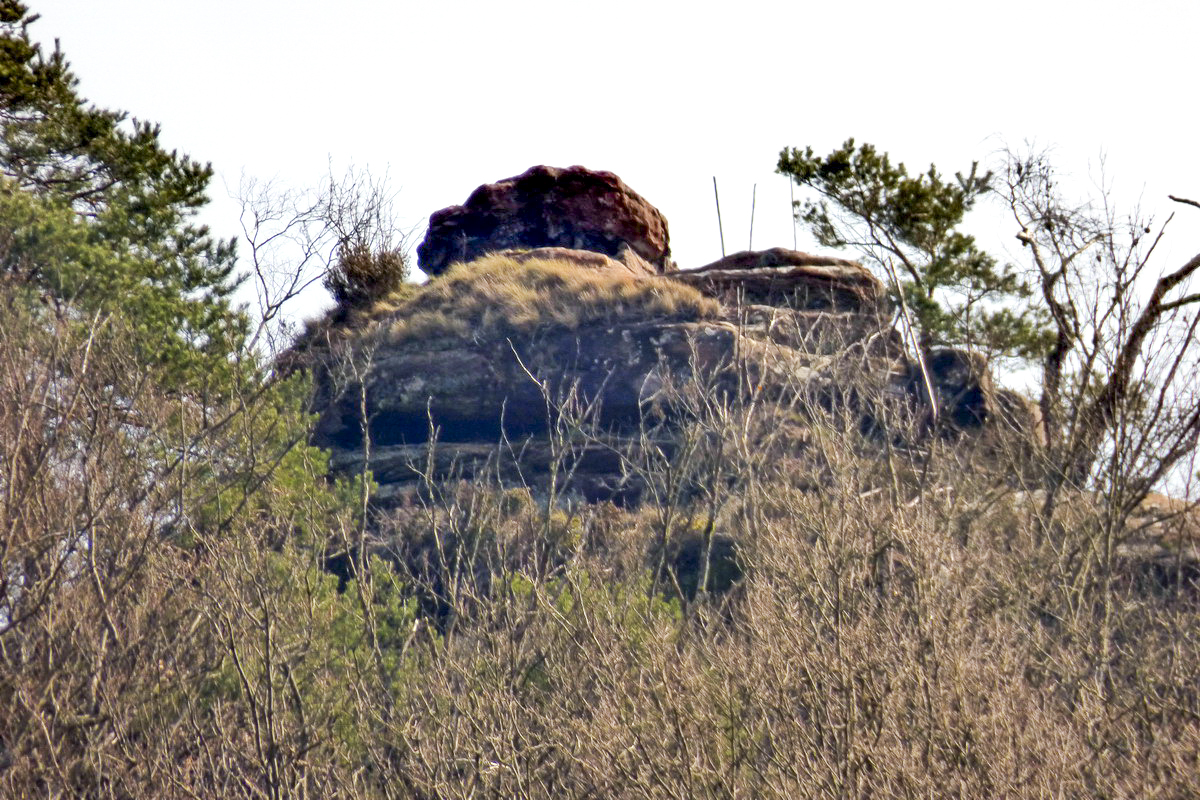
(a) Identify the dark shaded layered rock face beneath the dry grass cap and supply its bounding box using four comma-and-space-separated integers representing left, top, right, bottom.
304, 309, 833, 503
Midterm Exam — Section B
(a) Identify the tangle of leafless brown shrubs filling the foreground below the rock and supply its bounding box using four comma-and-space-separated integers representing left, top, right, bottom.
0, 241, 1200, 798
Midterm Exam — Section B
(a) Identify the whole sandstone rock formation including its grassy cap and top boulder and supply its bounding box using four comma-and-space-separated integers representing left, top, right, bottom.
290, 167, 1200, 606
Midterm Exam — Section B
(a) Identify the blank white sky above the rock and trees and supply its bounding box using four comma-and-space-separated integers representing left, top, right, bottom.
29, 0, 1200, 314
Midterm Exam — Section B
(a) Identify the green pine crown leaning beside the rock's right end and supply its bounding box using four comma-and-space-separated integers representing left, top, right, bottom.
776, 139, 1045, 356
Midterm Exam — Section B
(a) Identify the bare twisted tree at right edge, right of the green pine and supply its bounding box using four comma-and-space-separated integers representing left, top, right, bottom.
1001, 152, 1200, 501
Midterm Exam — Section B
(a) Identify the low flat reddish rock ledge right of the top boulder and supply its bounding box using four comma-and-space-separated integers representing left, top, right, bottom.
671, 247, 887, 315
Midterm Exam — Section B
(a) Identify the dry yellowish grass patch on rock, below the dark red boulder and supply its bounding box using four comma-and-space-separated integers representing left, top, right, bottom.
311, 255, 719, 343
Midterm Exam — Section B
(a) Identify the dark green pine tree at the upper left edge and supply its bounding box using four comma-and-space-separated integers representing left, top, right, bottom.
0, 0, 244, 377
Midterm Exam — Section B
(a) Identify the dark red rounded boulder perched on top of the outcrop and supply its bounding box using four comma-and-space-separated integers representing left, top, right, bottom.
416, 167, 673, 275
